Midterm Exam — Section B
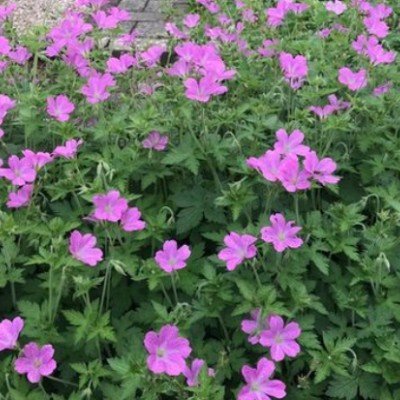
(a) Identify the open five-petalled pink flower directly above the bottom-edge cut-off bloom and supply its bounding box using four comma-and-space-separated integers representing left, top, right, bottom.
260, 315, 301, 361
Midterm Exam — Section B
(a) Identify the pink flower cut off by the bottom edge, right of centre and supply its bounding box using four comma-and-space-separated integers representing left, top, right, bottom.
238, 357, 286, 400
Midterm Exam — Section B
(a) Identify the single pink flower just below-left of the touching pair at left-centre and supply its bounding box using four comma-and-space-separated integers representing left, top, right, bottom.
69, 231, 103, 267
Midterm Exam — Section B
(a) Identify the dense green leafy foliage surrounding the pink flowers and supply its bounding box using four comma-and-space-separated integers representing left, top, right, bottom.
0, 0, 400, 400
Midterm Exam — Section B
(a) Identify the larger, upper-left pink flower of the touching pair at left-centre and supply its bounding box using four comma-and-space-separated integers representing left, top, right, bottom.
92, 190, 128, 222
